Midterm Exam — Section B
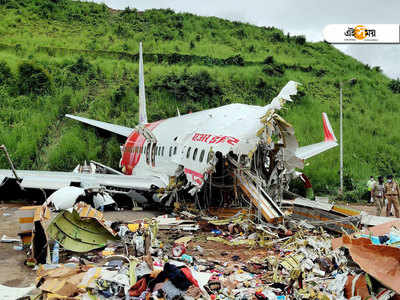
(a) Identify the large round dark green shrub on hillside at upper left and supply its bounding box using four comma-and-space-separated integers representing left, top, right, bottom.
18, 62, 50, 95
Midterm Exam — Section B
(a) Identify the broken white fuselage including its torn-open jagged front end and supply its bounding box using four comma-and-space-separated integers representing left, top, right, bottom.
120, 103, 303, 206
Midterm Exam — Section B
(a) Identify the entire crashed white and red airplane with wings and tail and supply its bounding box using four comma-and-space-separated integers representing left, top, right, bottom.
0, 44, 337, 221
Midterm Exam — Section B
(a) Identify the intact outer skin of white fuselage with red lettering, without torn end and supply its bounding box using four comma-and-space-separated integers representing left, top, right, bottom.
121, 103, 290, 185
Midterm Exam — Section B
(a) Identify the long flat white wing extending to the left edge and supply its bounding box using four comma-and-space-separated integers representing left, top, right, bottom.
0, 170, 167, 191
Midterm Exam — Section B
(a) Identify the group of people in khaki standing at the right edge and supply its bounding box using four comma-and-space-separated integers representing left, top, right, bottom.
367, 175, 400, 218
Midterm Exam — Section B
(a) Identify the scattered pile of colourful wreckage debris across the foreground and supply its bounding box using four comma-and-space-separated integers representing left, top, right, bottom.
3, 203, 400, 300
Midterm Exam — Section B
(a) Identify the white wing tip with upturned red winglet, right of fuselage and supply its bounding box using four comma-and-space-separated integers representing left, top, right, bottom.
296, 113, 338, 159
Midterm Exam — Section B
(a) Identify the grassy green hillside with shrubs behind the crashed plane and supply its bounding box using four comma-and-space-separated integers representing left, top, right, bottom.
0, 0, 400, 196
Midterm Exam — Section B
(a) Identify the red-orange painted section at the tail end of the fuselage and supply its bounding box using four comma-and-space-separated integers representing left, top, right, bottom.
121, 120, 163, 175
